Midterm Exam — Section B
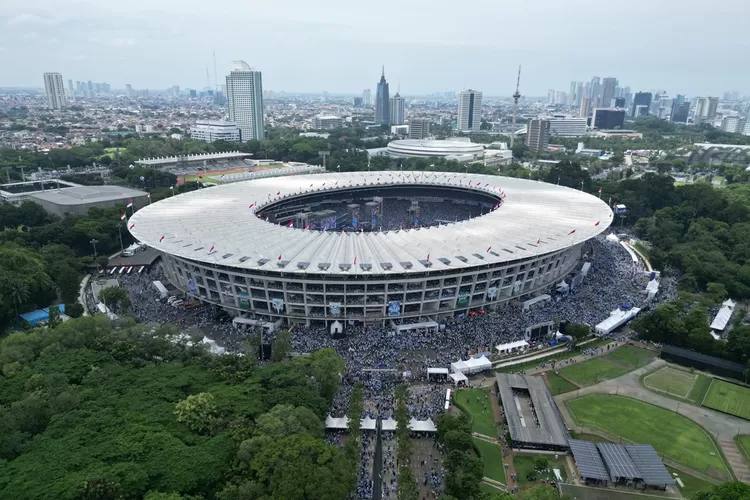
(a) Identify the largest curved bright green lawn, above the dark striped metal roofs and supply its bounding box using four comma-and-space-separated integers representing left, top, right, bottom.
566, 394, 729, 480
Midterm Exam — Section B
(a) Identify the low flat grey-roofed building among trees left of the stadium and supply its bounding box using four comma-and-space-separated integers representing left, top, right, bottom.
29, 186, 148, 217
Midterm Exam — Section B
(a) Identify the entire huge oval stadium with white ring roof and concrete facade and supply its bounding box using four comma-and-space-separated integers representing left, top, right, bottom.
128, 172, 612, 328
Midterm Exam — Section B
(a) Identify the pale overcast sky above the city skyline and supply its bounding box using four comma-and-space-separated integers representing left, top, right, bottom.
0, 0, 750, 96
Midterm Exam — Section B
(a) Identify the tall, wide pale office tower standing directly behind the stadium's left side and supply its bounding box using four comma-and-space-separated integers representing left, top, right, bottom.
226, 61, 265, 141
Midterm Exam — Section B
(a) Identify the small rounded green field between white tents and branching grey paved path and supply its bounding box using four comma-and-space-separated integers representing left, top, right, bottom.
560, 345, 656, 387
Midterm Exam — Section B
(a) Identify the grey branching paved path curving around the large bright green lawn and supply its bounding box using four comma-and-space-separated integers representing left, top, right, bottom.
555, 358, 750, 483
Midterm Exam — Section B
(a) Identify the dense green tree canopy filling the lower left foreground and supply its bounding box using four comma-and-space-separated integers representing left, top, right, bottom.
0, 317, 355, 500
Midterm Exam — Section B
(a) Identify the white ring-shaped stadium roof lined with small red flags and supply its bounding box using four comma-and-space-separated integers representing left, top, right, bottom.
128, 172, 612, 275
